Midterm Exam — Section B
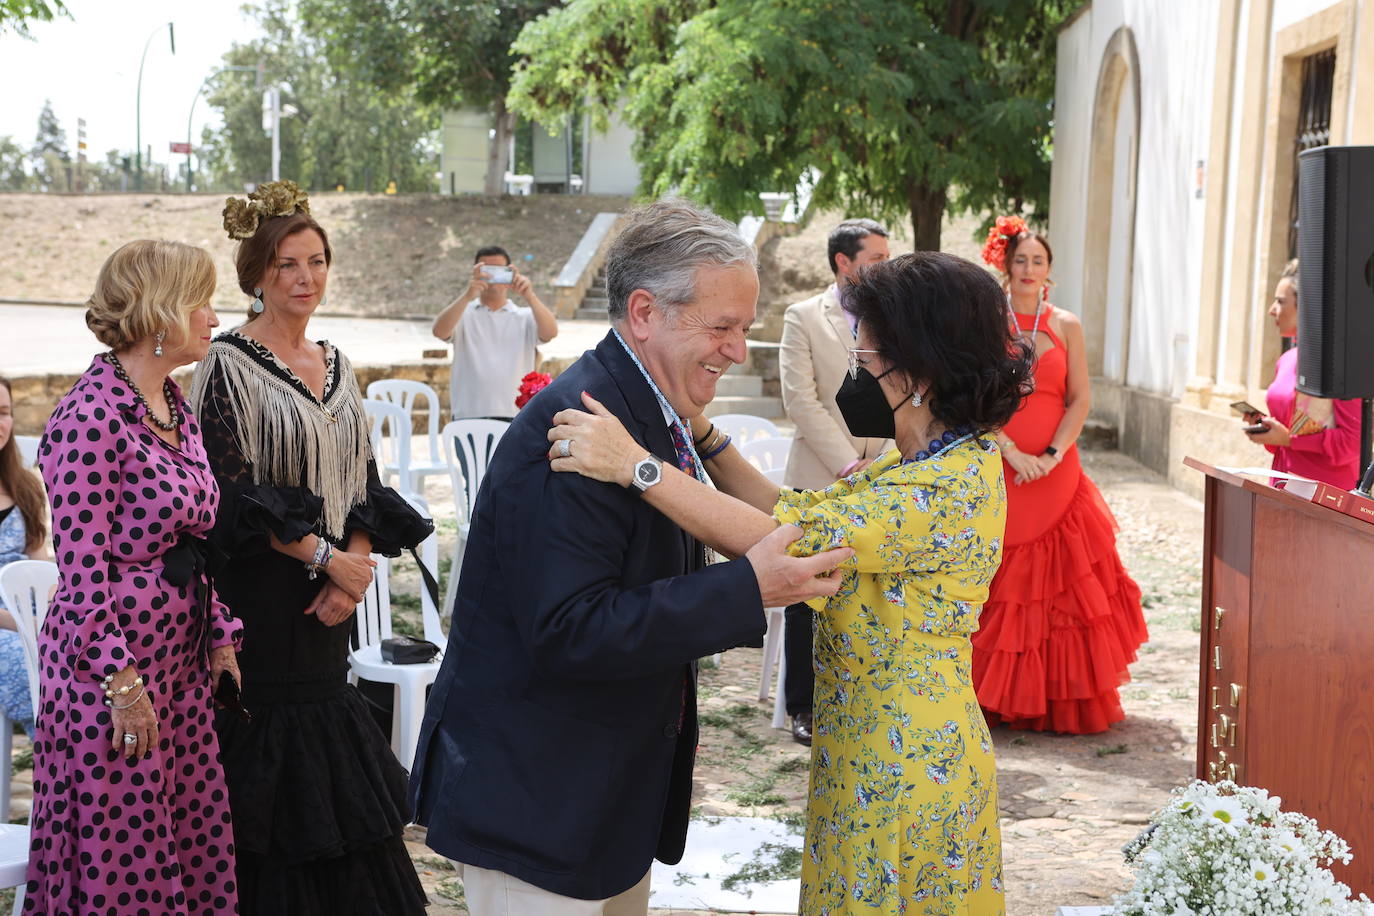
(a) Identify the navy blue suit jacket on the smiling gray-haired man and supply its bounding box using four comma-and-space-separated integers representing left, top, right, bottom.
411, 335, 765, 900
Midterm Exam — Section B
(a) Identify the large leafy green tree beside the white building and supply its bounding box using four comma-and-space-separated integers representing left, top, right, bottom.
510, 0, 1081, 249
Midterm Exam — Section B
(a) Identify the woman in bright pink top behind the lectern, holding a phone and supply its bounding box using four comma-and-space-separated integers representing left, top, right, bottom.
1245, 261, 1360, 490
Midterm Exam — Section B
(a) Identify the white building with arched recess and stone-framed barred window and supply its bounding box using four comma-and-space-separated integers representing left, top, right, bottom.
1050, 0, 1374, 493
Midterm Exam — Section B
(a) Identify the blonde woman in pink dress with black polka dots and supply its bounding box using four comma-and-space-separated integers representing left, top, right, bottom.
23, 242, 239, 916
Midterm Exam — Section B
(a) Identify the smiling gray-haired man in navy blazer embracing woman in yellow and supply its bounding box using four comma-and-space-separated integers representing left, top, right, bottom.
411, 201, 846, 916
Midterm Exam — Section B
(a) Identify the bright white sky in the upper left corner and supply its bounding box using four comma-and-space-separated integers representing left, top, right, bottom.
0, 0, 258, 163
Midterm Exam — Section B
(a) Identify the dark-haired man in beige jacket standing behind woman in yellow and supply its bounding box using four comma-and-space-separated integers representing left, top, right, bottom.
779, 220, 892, 744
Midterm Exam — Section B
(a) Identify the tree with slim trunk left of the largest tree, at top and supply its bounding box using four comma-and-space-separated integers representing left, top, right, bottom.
301, 0, 555, 194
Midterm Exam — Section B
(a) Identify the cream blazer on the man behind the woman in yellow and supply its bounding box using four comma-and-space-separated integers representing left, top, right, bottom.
778, 284, 892, 490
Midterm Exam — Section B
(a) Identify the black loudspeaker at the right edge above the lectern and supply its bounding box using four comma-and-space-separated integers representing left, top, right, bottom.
1297, 147, 1374, 398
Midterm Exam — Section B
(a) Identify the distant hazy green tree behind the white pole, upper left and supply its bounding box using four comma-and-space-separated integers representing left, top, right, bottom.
199, 0, 438, 191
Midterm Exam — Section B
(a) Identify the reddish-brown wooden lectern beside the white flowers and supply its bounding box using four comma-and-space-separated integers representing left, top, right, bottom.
1183, 457, 1374, 897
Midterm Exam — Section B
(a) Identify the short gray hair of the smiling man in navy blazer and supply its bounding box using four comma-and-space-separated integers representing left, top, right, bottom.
606, 198, 758, 321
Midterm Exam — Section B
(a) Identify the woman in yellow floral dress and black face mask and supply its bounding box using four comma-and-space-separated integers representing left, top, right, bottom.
550, 253, 1032, 916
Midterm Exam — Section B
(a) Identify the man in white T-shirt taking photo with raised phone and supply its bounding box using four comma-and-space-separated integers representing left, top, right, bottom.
433, 244, 558, 420
